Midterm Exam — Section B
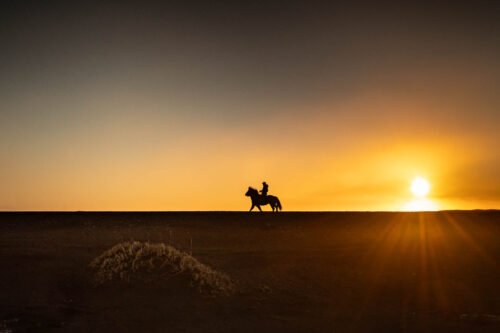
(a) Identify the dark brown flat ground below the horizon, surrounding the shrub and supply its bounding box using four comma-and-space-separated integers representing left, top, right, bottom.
0, 211, 500, 332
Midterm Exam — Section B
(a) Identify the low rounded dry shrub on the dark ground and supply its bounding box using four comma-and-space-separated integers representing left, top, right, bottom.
90, 242, 234, 295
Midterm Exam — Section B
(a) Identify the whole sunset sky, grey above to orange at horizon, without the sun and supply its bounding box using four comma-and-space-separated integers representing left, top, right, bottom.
0, 1, 500, 211
